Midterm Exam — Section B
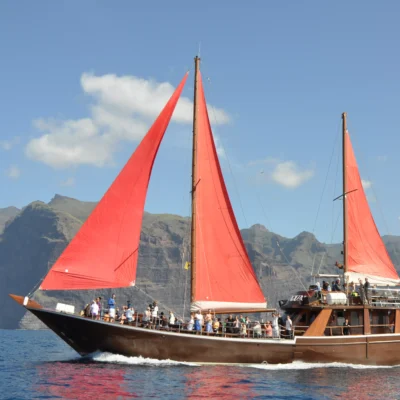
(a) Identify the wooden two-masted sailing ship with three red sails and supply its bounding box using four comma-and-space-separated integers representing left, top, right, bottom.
10, 57, 400, 365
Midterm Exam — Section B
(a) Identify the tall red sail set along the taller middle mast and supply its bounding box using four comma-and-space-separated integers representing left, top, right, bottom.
191, 72, 267, 310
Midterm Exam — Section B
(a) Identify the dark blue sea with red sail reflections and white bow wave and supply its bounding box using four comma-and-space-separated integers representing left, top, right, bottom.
0, 330, 400, 400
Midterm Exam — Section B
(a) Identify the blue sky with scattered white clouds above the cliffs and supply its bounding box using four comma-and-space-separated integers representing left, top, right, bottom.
0, 0, 400, 243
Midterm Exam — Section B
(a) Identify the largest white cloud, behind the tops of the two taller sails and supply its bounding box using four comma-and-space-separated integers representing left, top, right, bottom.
26, 73, 229, 168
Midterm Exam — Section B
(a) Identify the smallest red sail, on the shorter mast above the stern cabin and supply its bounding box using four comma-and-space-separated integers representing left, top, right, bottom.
345, 132, 400, 285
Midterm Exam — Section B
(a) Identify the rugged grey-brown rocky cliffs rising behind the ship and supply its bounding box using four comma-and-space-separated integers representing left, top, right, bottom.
0, 195, 400, 328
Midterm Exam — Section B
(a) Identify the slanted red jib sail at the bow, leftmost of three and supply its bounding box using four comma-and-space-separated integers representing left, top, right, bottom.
41, 74, 188, 290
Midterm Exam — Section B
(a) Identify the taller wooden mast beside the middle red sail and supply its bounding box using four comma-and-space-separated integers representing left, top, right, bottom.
190, 56, 200, 302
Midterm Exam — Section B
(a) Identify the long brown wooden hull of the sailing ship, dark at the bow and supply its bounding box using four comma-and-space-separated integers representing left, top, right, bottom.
28, 307, 400, 365
